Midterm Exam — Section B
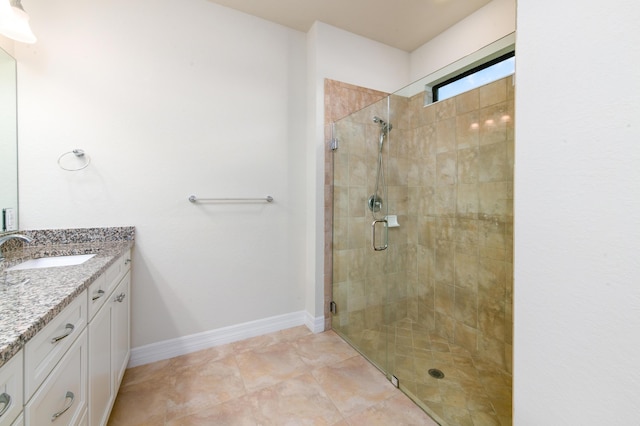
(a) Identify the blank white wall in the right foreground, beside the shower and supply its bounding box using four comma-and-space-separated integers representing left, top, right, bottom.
514, 0, 640, 426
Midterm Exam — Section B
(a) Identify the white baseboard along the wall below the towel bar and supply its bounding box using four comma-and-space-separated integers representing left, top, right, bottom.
128, 311, 324, 368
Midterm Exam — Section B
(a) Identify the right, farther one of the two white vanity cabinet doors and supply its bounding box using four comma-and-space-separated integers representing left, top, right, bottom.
111, 272, 131, 389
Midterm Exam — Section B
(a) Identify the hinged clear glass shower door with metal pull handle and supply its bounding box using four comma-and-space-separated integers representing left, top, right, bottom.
332, 98, 397, 371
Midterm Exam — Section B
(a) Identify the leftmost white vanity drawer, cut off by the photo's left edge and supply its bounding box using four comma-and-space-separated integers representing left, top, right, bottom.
0, 351, 23, 426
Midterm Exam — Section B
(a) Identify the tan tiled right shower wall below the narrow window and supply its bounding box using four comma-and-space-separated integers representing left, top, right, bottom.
407, 77, 515, 371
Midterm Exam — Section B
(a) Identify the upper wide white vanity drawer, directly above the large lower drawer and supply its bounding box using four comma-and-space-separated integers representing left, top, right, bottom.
24, 291, 87, 402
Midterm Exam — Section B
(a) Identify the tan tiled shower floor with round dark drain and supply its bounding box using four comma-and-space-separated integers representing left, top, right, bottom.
335, 319, 512, 426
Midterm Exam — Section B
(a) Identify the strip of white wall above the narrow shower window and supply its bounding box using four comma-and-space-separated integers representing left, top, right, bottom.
410, 0, 516, 82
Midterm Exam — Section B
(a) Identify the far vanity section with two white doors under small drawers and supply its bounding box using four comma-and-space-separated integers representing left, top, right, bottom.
88, 252, 130, 426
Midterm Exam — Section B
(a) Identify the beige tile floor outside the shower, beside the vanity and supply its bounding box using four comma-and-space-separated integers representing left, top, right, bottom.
108, 327, 436, 426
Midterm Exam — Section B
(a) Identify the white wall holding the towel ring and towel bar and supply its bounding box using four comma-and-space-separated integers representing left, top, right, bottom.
16, 0, 306, 347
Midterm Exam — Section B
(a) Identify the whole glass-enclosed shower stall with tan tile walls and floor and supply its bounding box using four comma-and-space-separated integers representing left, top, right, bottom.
328, 77, 514, 426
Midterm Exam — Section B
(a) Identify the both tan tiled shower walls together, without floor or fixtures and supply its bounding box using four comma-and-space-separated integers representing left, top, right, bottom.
325, 77, 514, 371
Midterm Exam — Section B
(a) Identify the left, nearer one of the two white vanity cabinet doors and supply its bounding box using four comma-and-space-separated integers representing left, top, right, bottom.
89, 295, 115, 426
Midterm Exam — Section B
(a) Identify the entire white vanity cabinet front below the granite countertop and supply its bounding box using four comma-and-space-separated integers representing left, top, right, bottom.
0, 245, 131, 426
